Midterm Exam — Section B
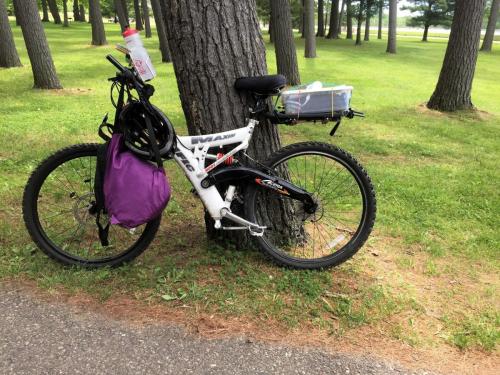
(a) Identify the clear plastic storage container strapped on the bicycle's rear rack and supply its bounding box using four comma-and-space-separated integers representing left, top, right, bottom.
280, 82, 353, 118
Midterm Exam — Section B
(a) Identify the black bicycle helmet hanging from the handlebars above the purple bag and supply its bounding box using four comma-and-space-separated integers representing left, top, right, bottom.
120, 101, 175, 160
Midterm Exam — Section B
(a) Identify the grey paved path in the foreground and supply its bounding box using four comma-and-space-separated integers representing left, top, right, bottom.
0, 286, 430, 375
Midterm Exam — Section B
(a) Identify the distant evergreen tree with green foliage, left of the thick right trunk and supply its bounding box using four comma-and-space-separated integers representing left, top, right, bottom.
401, 0, 455, 42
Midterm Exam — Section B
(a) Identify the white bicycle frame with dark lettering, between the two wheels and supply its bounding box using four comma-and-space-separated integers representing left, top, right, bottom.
174, 119, 265, 236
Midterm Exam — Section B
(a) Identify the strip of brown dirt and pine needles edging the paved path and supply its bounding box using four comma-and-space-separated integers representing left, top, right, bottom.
2, 281, 500, 375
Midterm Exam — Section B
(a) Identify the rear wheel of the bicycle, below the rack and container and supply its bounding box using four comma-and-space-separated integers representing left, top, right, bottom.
245, 142, 376, 269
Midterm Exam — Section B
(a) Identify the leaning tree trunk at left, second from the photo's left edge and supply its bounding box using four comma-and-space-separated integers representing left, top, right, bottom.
14, 0, 62, 89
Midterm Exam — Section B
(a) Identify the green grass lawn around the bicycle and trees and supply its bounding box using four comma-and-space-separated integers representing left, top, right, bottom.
0, 19, 500, 364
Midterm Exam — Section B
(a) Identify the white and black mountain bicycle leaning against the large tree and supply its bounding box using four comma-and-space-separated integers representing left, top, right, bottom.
23, 55, 376, 269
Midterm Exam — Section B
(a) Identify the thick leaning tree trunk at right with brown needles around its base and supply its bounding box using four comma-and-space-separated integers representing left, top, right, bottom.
427, 0, 485, 112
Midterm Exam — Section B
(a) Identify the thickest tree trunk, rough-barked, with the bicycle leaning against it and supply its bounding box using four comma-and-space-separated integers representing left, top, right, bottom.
161, 0, 290, 241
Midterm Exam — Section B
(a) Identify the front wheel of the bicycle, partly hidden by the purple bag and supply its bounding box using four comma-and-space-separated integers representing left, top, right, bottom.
23, 144, 161, 268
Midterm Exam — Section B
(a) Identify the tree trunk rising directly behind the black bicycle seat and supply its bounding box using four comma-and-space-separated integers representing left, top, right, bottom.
271, 0, 300, 85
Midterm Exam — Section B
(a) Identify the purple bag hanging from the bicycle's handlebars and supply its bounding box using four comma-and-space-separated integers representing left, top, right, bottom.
103, 134, 171, 228
